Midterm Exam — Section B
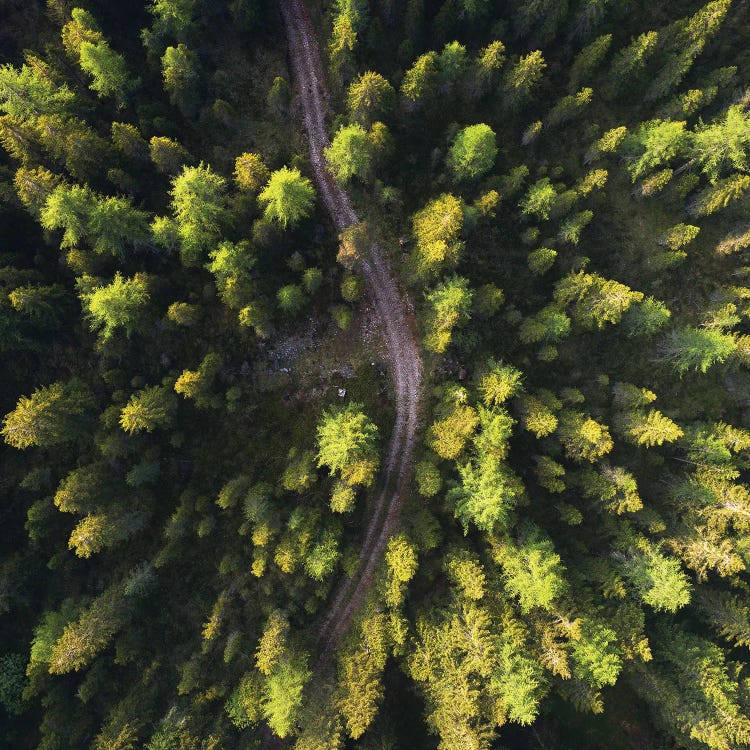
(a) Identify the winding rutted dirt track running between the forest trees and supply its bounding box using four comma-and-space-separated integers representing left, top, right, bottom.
280, 0, 422, 671
